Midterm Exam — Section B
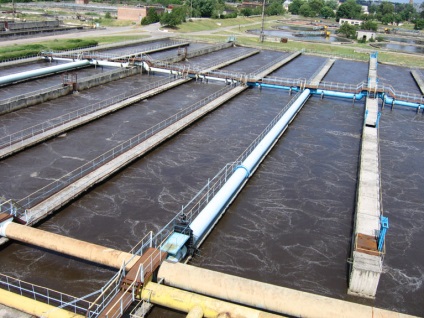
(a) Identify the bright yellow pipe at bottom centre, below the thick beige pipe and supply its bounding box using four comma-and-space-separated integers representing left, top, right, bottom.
141, 282, 281, 318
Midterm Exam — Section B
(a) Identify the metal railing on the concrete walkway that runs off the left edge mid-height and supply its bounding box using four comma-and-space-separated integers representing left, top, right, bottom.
0, 76, 175, 153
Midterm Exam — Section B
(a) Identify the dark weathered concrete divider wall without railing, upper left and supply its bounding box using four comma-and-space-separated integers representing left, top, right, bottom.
0, 67, 141, 115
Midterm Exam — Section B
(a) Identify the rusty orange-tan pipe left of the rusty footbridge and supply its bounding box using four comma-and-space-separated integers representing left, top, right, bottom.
3, 222, 139, 270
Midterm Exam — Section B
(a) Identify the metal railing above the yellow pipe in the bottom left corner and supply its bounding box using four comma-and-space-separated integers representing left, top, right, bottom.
0, 274, 98, 314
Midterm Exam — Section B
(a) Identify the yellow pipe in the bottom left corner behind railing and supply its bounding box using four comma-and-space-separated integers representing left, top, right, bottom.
0, 289, 85, 318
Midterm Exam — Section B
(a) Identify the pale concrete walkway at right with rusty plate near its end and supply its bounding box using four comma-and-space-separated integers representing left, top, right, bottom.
348, 55, 384, 299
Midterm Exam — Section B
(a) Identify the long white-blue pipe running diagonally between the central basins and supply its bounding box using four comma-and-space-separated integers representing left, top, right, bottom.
190, 89, 310, 243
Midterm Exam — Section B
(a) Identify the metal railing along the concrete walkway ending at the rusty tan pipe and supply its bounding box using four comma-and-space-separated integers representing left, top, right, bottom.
5, 86, 233, 223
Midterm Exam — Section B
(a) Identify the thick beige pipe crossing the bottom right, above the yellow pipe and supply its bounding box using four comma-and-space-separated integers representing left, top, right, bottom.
158, 261, 418, 318
